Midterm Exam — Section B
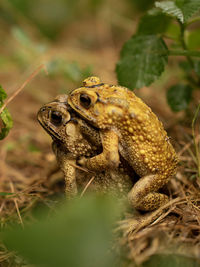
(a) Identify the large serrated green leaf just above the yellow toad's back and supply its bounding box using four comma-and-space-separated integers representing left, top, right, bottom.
116, 35, 168, 89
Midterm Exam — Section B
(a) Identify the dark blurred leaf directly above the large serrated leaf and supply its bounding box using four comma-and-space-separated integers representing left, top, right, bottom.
137, 12, 170, 35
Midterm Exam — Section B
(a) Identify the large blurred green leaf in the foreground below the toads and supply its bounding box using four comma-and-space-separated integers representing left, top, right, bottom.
3, 196, 119, 267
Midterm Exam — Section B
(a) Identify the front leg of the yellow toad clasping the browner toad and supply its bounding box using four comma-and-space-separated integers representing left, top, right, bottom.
79, 130, 119, 171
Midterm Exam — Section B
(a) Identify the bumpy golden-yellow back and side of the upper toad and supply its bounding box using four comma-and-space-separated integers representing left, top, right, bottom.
69, 78, 177, 180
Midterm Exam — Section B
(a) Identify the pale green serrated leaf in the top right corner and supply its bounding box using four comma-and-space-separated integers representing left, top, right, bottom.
155, 0, 200, 23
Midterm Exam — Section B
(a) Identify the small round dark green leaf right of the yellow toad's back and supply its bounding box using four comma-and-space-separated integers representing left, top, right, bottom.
167, 84, 193, 112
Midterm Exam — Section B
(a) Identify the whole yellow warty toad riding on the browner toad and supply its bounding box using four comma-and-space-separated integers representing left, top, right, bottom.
68, 77, 177, 211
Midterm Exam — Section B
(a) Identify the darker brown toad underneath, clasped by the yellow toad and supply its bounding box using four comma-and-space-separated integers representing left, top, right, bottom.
38, 95, 133, 198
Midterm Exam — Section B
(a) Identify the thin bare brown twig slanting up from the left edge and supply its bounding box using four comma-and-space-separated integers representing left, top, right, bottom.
0, 64, 48, 114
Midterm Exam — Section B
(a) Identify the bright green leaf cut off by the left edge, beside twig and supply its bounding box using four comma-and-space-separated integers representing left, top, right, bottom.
0, 86, 13, 140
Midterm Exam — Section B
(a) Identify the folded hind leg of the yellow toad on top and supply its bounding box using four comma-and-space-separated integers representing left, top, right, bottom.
128, 175, 169, 211
